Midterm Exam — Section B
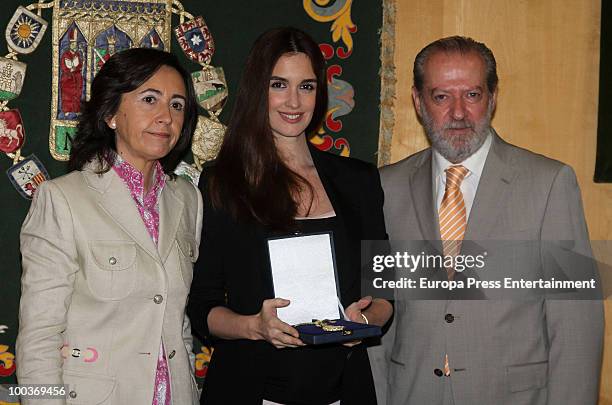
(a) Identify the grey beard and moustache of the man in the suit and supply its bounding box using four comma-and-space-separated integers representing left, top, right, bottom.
421, 101, 493, 163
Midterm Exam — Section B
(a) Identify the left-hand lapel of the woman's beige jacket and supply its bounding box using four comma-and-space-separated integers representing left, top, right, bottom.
85, 169, 159, 261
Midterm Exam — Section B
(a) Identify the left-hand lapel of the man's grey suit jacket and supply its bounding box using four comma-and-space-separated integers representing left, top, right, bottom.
410, 151, 440, 241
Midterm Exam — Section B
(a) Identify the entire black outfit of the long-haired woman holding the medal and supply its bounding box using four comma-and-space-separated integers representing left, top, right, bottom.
187, 148, 386, 405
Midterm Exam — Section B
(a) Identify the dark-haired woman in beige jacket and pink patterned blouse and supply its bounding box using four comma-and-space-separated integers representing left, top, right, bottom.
17, 49, 202, 405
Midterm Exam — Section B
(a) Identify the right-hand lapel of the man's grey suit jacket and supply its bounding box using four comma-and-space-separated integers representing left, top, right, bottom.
464, 133, 516, 240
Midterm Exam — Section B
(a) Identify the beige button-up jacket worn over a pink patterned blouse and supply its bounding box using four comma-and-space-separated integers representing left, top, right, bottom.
16, 168, 202, 405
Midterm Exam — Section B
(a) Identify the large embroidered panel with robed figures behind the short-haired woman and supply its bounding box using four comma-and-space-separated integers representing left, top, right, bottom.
49, 0, 172, 160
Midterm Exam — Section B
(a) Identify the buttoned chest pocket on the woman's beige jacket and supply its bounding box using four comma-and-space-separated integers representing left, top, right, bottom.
85, 240, 136, 300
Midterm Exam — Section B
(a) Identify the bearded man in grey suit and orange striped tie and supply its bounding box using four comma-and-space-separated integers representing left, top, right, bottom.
374, 37, 603, 405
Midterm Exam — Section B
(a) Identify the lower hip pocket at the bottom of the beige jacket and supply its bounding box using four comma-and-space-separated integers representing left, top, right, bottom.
64, 370, 115, 405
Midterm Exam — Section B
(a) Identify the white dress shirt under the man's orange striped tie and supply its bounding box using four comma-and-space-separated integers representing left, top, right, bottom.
431, 133, 493, 220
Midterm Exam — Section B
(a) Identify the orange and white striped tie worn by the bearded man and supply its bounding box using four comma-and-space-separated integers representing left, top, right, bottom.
438, 166, 469, 376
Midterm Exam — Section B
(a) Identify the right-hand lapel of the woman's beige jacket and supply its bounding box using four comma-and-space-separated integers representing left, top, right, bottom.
158, 180, 185, 263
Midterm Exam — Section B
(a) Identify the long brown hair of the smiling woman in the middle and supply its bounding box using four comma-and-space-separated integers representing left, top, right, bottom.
209, 27, 327, 230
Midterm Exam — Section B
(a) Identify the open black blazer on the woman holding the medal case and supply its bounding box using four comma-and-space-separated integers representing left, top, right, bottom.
188, 147, 386, 405
